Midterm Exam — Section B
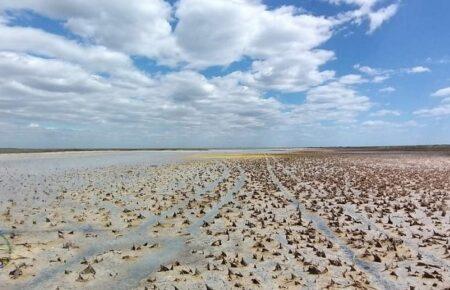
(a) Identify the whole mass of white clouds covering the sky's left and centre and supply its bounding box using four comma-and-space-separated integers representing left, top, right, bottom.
0, 0, 402, 145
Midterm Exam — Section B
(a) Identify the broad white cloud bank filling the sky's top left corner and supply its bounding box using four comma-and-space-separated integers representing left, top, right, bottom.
0, 0, 177, 60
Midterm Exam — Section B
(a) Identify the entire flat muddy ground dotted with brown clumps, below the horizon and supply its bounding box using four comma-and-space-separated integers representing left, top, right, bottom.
0, 148, 450, 289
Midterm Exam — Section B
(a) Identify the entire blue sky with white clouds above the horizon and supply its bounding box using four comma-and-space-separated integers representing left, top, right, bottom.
0, 0, 450, 148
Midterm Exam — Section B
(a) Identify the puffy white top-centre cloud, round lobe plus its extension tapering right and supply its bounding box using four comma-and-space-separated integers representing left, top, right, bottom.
175, 0, 333, 66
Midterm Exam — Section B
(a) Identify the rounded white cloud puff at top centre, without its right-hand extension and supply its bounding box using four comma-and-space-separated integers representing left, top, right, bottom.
175, 0, 265, 66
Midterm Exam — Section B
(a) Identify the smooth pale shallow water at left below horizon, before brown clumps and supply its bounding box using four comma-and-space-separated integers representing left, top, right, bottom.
0, 151, 200, 205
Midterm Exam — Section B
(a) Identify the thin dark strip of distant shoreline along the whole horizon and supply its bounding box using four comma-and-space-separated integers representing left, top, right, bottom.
0, 144, 450, 154
